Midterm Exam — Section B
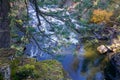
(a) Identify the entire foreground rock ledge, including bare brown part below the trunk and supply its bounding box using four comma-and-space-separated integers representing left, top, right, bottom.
0, 49, 70, 80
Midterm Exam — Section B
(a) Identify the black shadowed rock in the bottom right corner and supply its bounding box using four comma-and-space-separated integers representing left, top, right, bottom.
104, 53, 120, 80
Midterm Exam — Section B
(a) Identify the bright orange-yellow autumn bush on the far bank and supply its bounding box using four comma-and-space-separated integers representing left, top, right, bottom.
91, 9, 113, 23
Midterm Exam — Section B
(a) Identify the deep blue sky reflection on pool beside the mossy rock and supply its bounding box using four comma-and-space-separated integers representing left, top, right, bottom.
59, 54, 86, 80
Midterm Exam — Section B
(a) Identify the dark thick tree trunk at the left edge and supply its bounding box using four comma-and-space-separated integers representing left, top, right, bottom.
0, 0, 10, 48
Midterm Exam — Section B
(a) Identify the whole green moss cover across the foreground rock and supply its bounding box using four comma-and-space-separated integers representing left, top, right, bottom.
11, 58, 64, 80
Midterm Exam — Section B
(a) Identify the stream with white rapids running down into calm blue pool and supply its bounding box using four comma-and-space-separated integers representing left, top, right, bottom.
26, 4, 106, 80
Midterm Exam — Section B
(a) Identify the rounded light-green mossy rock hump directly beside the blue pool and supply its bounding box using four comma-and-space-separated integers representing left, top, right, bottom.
35, 60, 64, 80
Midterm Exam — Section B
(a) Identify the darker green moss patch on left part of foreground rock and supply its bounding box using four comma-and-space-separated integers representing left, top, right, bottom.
11, 57, 38, 80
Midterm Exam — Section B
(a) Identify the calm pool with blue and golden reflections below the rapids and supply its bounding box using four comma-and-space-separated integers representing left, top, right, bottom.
57, 44, 107, 80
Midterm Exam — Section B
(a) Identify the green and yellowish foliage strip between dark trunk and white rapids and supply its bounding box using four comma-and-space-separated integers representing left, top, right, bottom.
9, 0, 28, 55
